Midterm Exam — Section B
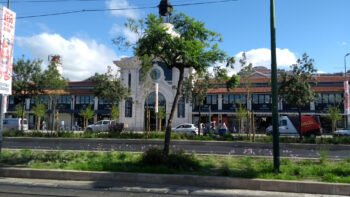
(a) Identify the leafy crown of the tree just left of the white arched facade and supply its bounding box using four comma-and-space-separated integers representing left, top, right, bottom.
92, 66, 129, 106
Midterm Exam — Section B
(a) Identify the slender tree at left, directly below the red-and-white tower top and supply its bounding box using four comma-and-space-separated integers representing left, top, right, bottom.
42, 55, 68, 130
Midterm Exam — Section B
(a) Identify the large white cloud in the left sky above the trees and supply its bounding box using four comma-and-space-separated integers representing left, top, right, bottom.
16, 33, 117, 81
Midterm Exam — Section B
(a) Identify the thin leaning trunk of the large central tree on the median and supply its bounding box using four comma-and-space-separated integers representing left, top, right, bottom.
163, 67, 185, 157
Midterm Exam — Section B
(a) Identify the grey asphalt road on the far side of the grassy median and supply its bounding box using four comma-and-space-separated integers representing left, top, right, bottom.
2, 138, 350, 159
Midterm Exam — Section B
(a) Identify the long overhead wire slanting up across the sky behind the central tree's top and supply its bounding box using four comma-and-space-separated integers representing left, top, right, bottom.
16, 0, 238, 19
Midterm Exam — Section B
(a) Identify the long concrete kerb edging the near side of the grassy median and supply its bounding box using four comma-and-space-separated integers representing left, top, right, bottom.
0, 168, 350, 196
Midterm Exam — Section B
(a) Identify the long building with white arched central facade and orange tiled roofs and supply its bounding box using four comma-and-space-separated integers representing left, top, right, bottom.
6, 57, 346, 132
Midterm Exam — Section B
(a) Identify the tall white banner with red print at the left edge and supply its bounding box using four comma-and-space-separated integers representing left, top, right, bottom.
0, 7, 16, 95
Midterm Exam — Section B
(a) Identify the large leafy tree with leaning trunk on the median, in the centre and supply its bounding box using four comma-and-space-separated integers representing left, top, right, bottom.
131, 14, 227, 157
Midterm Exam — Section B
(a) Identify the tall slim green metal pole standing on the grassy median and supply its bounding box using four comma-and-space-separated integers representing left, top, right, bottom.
270, 0, 280, 173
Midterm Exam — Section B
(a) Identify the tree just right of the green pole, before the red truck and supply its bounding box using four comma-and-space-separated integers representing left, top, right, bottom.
279, 53, 317, 139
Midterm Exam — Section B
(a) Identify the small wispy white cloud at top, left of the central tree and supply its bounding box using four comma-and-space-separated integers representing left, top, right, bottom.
106, 0, 139, 19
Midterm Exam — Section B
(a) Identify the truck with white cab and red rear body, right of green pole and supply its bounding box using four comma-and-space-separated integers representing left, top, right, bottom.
266, 115, 322, 137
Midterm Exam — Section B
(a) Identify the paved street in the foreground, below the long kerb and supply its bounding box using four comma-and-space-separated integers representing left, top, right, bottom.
0, 178, 341, 197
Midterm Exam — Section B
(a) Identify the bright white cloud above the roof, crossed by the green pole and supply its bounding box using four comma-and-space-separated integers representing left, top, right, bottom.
209, 48, 297, 75
